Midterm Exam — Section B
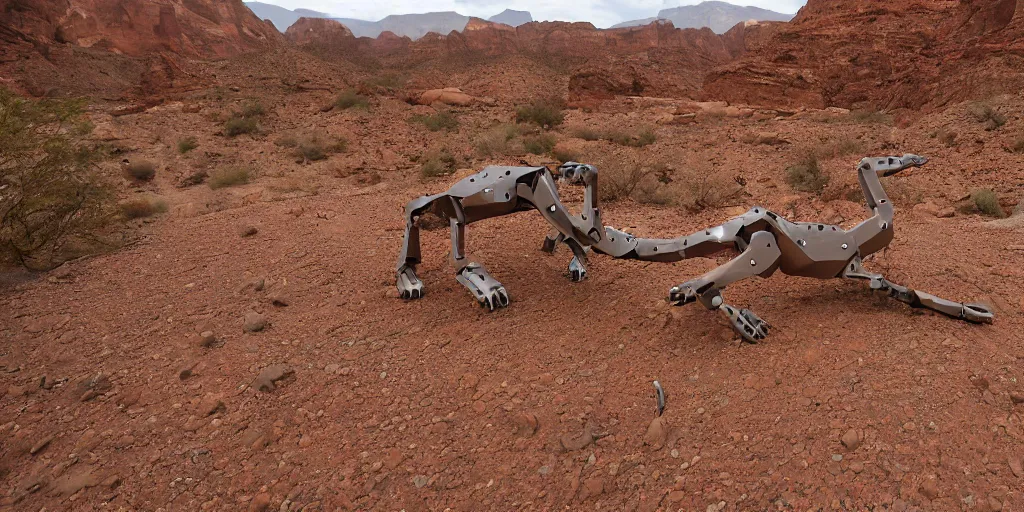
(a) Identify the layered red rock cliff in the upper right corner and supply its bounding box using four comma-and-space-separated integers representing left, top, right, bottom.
703, 0, 1024, 109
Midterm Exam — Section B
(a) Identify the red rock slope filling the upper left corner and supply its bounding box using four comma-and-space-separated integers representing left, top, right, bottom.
0, 0, 282, 58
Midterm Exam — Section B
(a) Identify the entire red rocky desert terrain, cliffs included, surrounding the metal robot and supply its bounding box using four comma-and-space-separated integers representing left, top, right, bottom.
6, 0, 1024, 512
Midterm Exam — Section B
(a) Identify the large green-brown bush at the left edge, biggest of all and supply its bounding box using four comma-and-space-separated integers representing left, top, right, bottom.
0, 87, 114, 269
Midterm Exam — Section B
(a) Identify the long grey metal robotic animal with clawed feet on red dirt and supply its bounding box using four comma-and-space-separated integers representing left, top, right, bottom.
396, 155, 993, 343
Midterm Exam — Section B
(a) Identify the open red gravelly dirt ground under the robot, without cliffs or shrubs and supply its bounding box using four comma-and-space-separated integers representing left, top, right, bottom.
0, 2, 1024, 511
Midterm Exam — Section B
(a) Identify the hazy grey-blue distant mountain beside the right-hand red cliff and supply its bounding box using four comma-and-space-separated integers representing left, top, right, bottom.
611, 1, 795, 34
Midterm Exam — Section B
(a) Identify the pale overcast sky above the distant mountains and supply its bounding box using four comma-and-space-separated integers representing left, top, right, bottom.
253, 0, 807, 28
